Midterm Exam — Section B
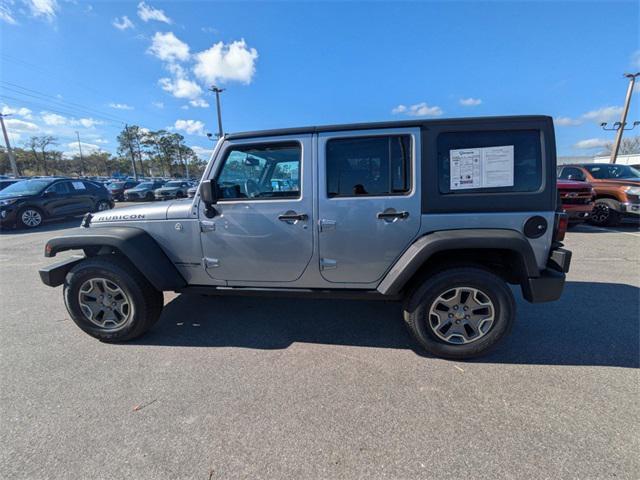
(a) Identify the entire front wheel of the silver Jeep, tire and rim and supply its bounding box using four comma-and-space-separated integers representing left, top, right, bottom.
64, 255, 164, 342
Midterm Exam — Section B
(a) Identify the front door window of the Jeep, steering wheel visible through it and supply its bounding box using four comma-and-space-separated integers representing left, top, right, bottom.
217, 143, 302, 199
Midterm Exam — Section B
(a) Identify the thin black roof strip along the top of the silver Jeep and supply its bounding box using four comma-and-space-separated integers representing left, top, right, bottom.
225, 115, 553, 139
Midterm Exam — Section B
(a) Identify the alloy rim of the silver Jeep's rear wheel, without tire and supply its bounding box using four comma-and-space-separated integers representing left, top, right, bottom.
428, 287, 496, 345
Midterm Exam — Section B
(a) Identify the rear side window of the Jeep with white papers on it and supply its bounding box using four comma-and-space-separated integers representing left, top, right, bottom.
437, 130, 542, 194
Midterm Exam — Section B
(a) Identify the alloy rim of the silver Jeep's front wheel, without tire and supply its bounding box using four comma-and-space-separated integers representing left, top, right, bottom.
78, 278, 133, 331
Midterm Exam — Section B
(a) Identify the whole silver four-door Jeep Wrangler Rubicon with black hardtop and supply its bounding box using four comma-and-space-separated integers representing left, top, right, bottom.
40, 116, 571, 359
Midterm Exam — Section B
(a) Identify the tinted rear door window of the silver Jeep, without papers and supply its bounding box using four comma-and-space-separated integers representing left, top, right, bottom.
326, 135, 411, 197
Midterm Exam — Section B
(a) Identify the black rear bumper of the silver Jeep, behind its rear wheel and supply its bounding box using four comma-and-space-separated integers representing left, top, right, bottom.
522, 248, 571, 303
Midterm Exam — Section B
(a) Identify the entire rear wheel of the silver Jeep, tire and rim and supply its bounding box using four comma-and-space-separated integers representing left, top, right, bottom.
404, 267, 516, 360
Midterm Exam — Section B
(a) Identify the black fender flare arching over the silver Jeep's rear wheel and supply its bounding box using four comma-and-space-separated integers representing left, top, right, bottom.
378, 228, 540, 295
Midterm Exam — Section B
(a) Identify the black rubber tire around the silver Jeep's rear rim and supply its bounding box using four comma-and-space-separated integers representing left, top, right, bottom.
404, 267, 516, 360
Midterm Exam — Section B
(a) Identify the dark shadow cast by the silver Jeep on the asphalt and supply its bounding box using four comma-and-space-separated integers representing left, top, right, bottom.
134, 282, 640, 368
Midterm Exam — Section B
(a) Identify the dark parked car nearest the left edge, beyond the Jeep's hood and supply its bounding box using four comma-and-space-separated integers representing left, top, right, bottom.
0, 178, 113, 228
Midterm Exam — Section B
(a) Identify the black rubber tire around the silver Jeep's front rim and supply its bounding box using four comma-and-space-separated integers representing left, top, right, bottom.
64, 255, 164, 342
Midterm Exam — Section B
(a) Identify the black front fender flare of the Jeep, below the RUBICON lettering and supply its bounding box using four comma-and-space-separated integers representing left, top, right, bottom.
44, 227, 187, 291
